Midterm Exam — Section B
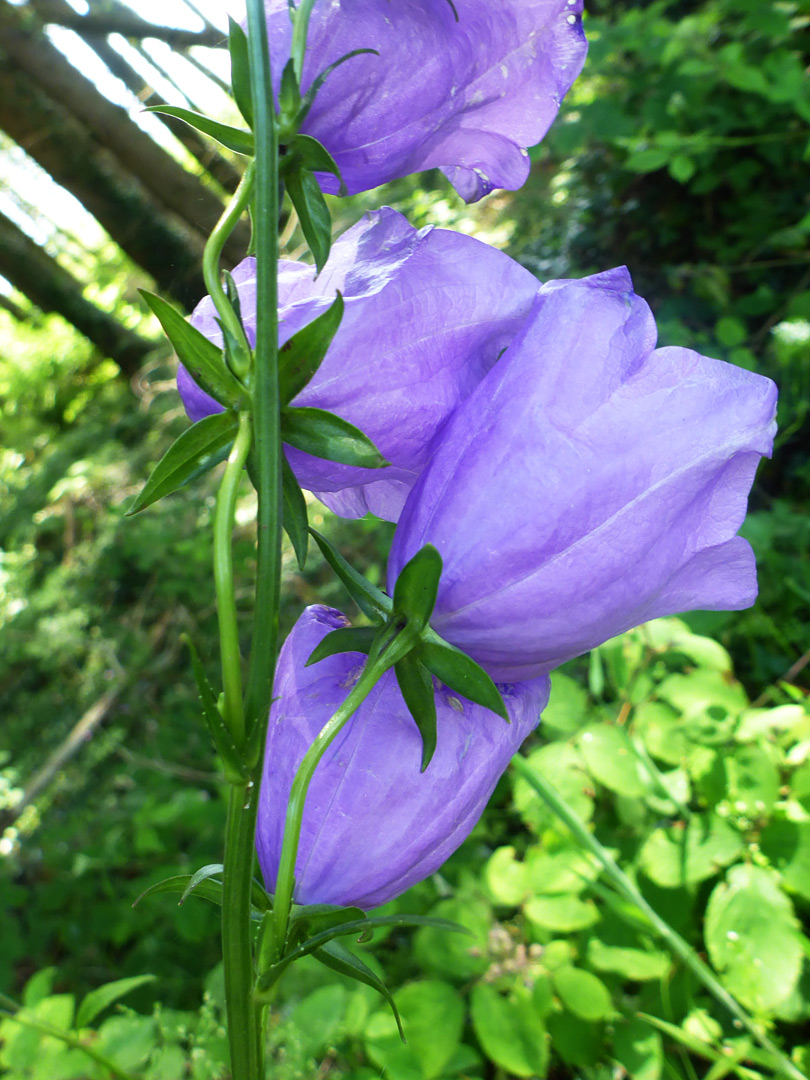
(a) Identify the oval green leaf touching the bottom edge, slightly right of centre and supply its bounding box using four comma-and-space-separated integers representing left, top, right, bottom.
470, 983, 550, 1077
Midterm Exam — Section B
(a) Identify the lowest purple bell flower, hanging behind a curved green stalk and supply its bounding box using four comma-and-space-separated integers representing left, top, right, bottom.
256, 606, 549, 909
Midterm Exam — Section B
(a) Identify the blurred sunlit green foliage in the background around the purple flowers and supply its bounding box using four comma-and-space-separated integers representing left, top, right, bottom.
0, 0, 810, 1080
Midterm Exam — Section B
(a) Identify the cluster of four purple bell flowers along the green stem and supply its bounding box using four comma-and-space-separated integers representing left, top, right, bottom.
179, 0, 775, 906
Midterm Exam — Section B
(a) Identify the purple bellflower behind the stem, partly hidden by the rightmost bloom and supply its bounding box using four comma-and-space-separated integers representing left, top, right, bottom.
177, 207, 539, 521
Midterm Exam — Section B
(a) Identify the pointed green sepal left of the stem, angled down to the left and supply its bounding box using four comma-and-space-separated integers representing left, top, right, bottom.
126, 413, 239, 517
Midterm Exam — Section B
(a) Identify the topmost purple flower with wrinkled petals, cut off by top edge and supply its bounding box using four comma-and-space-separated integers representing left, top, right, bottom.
266, 0, 588, 202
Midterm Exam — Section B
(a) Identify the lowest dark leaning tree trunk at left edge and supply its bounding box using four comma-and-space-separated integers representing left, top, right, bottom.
0, 206, 154, 376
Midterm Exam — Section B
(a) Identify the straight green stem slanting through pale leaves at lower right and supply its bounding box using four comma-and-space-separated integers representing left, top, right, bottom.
512, 755, 808, 1080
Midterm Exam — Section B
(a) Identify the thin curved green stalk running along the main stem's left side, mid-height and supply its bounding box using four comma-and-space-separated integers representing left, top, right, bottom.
214, 413, 251, 747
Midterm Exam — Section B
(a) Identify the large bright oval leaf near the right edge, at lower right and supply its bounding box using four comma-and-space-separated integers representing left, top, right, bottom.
704, 865, 802, 1013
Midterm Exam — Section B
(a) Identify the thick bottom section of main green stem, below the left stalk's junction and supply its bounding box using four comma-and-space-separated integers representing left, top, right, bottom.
222, 778, 265, 1080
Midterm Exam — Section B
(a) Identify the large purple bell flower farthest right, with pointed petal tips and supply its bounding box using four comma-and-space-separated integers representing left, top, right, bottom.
389, 269, 777, 679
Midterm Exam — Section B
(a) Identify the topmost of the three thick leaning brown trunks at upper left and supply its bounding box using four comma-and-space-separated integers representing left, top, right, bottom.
0, 0, 249, 264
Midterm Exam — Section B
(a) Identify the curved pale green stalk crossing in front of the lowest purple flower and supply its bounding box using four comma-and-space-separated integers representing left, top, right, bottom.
272, 658, 391, 962
